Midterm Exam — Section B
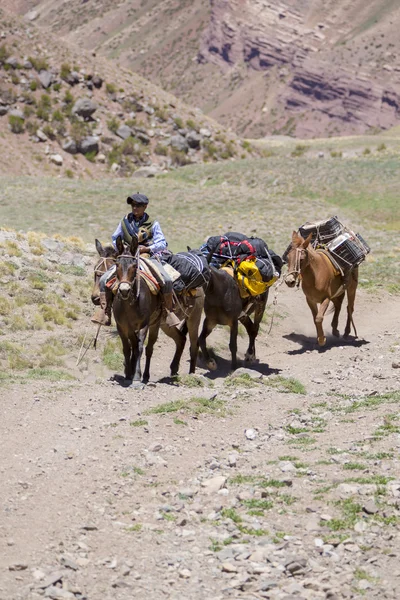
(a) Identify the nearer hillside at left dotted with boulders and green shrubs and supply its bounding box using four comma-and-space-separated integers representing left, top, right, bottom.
0, 11, 251, 178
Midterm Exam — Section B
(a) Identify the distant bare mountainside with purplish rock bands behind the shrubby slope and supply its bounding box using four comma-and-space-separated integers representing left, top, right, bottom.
6, 0, 400, 137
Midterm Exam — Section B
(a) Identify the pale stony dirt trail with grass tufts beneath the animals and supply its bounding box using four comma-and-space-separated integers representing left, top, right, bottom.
0, 286, 400, 600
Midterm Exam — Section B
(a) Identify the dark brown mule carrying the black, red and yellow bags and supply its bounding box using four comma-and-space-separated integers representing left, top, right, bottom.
199, 267, 268, 370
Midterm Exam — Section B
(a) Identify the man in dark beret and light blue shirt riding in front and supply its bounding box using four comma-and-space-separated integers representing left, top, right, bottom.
91, 194, 181, 327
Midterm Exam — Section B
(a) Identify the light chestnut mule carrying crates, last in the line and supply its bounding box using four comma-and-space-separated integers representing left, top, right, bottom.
285, 231, 358, 346
